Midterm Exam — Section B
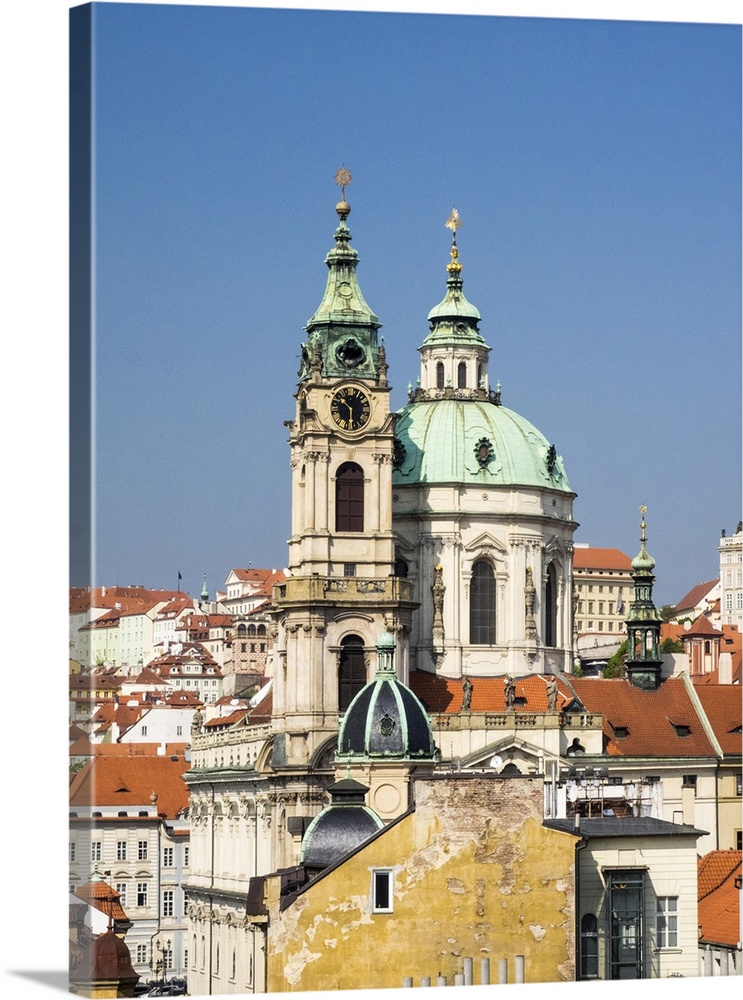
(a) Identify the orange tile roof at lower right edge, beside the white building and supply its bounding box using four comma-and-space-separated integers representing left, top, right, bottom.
697, 851, 741, 948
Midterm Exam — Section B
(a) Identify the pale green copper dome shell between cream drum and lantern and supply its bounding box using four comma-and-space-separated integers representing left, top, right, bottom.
392, 399, 572, 493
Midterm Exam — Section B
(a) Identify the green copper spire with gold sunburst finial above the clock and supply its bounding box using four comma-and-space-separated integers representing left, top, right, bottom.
299, 167, 382, 381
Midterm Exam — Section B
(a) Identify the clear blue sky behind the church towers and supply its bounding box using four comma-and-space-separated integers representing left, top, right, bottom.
75, 4, 741, 602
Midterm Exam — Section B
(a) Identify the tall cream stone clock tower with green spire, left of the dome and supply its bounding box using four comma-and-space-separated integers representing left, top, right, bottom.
272, 169, 416, 767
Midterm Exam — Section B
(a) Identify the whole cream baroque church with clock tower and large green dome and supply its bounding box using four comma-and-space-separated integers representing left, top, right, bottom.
185, 184, 580, 994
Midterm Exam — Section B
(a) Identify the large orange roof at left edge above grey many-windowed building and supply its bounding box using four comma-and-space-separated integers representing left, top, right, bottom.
70, 754, 190, 819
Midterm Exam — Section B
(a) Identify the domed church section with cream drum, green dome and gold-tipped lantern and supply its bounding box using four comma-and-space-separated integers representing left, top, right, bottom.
392, 211, 576, 678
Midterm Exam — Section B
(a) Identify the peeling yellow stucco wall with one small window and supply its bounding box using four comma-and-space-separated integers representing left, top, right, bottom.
267, 775, 575, 992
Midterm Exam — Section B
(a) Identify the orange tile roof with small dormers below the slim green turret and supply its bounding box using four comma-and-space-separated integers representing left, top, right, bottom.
570, 677, 715, 758
